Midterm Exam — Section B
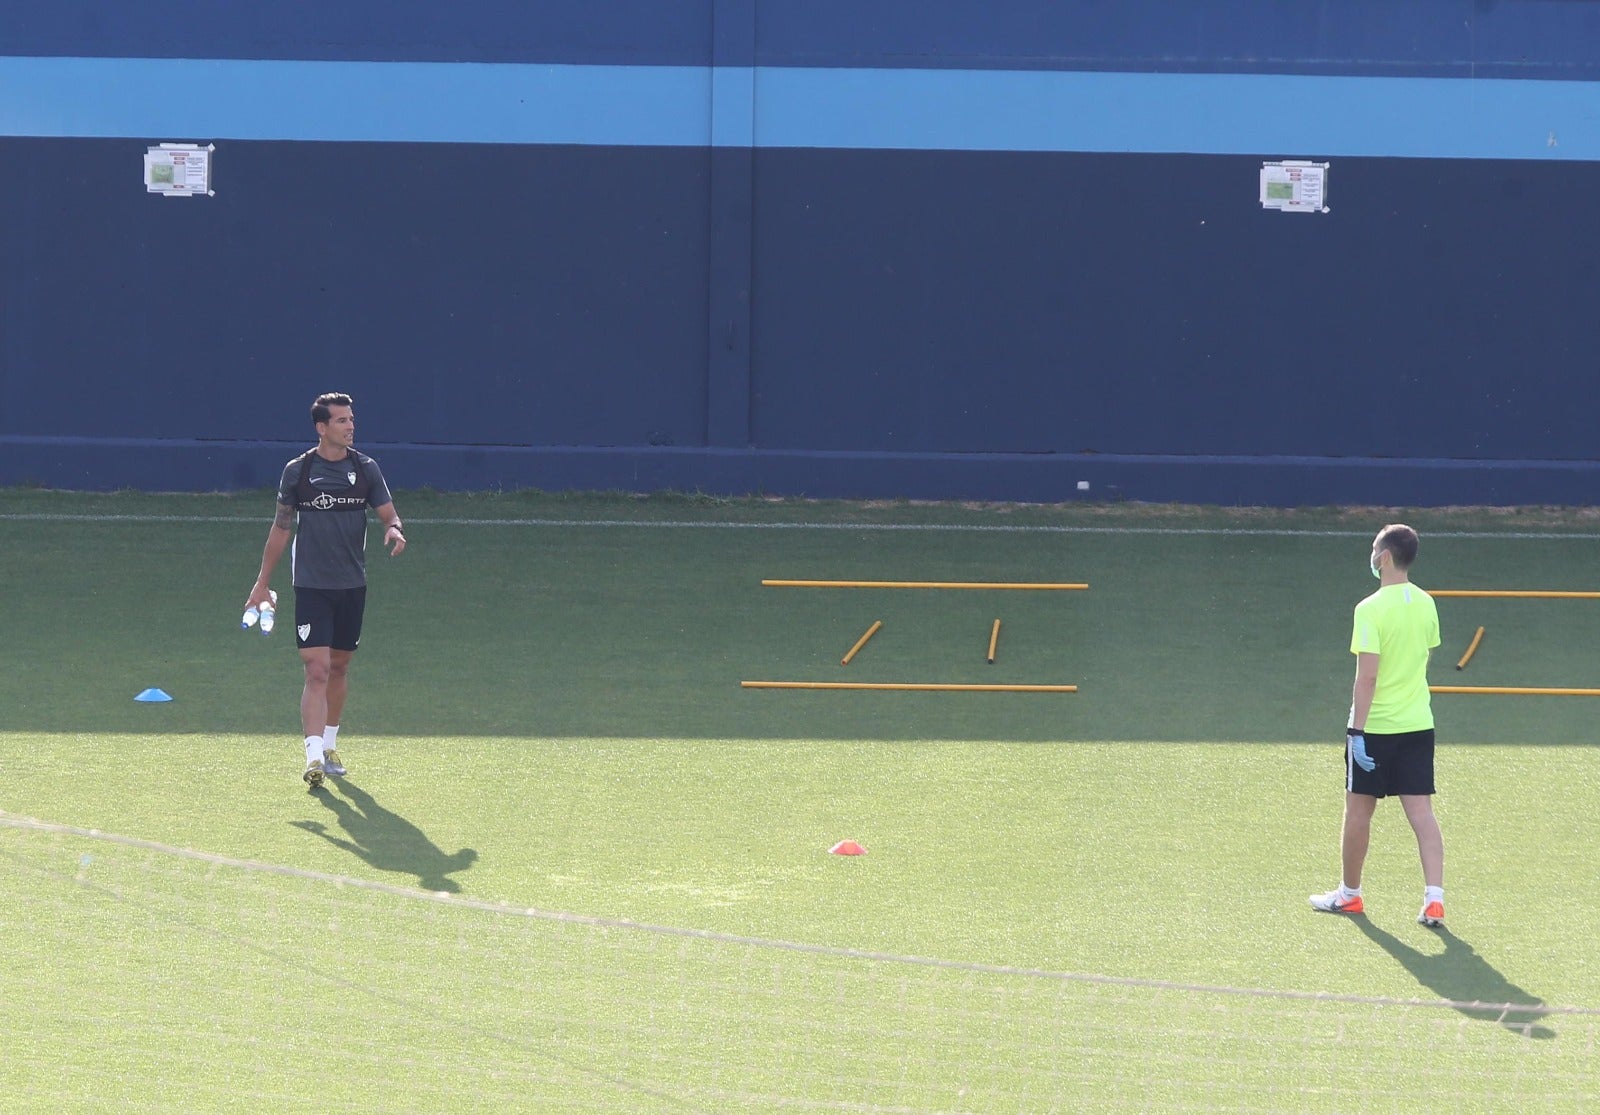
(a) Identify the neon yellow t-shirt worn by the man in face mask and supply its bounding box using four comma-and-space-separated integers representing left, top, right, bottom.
1350, 582, 1438, 734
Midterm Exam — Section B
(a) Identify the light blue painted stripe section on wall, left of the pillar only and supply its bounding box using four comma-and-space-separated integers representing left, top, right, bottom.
0, 58, 710, 147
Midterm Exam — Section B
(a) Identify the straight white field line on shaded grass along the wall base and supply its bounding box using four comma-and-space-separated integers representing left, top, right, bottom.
0, 512, 1600, 542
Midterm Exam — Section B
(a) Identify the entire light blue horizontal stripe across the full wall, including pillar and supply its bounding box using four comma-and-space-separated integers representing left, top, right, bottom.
9, 58, 1600, 160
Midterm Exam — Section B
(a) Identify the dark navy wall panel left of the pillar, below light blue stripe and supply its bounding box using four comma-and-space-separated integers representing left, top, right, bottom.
0, 139, 707, 445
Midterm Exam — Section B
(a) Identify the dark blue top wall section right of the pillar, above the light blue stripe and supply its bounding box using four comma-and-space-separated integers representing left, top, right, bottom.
757, 0, 1600, 78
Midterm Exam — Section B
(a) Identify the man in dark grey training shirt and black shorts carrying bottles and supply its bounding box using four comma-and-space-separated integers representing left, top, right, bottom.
246, 392, 405, 790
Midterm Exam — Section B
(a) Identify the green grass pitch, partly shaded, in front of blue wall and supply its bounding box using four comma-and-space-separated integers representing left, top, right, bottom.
0, 490, 1600, 1112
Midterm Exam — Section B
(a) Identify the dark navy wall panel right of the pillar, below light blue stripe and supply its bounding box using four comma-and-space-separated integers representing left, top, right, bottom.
754, 150, 1600, 459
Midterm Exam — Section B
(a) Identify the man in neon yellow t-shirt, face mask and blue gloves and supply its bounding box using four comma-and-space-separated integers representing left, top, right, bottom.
1310, 523, 1445, 926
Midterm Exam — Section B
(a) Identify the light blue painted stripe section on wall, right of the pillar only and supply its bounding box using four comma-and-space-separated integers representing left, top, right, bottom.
755, 69, 1600, 160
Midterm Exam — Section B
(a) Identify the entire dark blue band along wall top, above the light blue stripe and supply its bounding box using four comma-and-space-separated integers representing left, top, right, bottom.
12, 0, 1600, 78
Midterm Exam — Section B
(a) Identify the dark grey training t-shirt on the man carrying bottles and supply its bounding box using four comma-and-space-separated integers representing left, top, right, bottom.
278, 450, 394, 589
